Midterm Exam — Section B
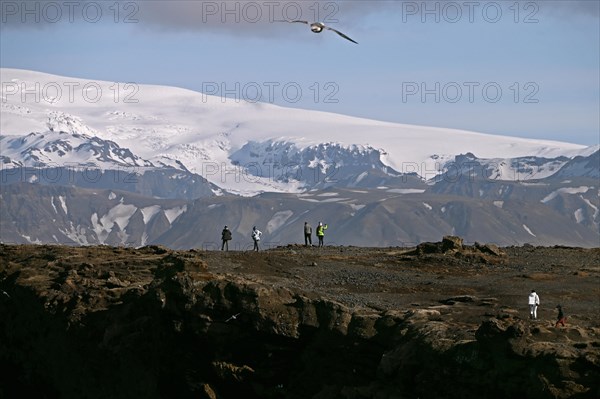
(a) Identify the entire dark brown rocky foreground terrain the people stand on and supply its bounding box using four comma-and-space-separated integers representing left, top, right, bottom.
0, 237, 600, 399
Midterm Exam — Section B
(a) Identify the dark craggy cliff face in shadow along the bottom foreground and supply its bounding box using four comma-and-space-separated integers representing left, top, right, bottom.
0, 246, 600, 399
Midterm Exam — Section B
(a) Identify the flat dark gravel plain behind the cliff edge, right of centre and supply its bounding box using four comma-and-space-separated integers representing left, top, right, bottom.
202, 246, 600, 326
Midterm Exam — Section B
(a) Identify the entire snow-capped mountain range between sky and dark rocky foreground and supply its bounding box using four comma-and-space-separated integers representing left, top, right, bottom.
0, 69, 600, 249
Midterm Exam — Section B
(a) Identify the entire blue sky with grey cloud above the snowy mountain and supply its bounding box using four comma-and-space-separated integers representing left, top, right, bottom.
0, 0, 600, 145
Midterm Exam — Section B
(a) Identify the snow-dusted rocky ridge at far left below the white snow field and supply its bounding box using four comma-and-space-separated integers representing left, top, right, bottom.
0, 130, 221, 199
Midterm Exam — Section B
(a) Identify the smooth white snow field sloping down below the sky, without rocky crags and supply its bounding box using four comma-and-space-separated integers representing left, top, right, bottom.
0, 68, 598, 197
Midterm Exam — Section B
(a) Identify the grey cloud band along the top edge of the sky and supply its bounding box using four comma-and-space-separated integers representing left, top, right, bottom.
0, 0, 600, 32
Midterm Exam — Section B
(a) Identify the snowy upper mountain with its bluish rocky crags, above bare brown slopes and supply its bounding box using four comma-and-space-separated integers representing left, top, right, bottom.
0, 69, 589, 195
